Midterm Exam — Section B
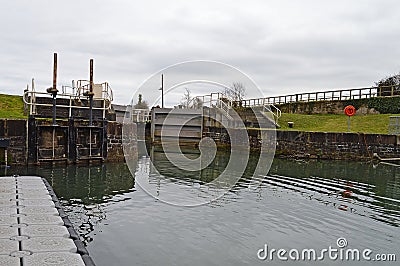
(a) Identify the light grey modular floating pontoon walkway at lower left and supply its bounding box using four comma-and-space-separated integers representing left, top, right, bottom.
0, 176, 94, 266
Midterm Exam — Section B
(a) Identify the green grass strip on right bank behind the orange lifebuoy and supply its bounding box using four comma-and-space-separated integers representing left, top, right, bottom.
278, 113, 393, 134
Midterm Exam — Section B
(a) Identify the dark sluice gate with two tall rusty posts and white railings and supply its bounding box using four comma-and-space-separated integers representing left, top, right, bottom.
23, 54, 112, 164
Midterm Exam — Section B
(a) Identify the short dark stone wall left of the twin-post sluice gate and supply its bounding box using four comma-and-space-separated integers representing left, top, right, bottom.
0, 119, 27, 164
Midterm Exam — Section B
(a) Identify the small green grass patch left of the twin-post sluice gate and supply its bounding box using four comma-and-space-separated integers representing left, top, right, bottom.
0, 94, 27, 118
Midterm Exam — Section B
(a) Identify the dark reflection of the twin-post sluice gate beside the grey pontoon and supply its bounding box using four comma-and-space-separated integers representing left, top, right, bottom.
0, 164, 135, 244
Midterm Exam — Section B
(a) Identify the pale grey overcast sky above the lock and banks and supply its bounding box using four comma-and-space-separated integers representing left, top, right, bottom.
0, 0, 400, 104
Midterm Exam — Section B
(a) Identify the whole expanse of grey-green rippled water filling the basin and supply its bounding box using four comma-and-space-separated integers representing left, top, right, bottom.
1, 152, 400, 265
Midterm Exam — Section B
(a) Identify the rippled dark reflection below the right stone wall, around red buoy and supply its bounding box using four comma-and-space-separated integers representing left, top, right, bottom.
265, 160, 400, 227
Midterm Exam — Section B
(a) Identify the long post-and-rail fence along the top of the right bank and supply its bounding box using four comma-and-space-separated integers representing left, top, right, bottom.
240, 86, 400, 107
